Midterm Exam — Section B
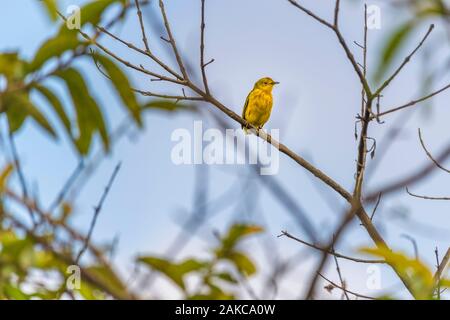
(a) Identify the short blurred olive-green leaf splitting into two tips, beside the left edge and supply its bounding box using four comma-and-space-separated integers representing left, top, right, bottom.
3, 93, 56, 138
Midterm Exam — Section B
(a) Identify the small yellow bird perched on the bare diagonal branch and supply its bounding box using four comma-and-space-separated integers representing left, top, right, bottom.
242, 77, 279, 133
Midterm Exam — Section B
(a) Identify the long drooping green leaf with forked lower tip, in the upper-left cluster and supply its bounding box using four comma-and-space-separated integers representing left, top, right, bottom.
56, 68, 109, 155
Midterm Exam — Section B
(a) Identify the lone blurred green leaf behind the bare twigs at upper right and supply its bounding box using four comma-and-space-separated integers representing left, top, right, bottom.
374, 21, 416, 82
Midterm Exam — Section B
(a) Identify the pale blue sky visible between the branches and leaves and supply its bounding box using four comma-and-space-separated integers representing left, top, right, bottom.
0, 0, 450, 298
